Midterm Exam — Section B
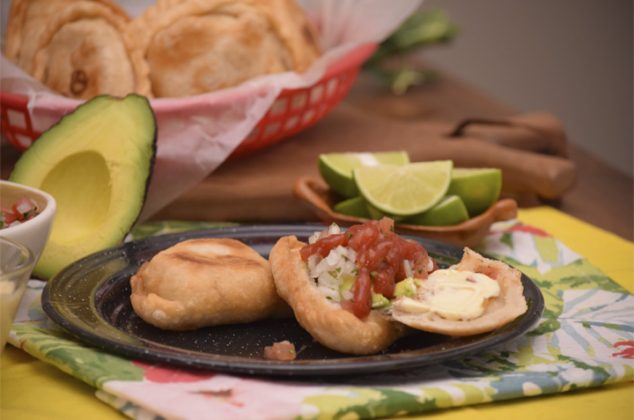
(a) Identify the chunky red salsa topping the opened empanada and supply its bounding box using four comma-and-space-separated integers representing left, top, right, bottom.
300, 218, 436, 318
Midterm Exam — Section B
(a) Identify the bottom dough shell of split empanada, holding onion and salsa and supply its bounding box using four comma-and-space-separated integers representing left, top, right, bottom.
269, 236, 405, 354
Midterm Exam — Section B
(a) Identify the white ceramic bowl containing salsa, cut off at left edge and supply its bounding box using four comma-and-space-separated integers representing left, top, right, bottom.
0, 180, 57, 262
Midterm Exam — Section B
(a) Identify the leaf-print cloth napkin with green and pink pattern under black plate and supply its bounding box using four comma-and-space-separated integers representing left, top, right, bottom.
9, 222, 634, 419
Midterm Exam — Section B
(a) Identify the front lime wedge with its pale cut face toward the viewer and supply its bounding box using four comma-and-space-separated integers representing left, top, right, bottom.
353, 160, 453, 216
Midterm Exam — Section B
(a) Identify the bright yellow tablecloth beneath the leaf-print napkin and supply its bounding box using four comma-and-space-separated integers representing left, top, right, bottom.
0, 207, 634, 420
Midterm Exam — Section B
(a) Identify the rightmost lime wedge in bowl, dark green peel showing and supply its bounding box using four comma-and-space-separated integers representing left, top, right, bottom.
447, 168, 502, 217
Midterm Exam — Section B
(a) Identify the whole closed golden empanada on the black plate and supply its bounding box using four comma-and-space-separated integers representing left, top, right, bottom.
130, 238, 289, 331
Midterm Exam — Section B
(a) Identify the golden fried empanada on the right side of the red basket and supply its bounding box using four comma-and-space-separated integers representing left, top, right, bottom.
130, 0, 320, 97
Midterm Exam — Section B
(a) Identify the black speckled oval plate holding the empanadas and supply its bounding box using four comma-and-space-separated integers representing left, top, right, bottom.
42, 224, 544, 376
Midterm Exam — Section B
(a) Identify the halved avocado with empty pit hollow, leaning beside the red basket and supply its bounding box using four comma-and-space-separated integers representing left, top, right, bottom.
9, 94, 157, 279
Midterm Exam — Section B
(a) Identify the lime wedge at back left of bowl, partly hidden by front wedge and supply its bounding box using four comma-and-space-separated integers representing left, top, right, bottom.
318, 151, 409, 198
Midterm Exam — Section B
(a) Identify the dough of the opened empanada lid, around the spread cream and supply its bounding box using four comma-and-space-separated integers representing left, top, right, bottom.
392, 248, 528, 336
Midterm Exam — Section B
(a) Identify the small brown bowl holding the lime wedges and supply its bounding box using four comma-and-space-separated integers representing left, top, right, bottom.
293, 177, 517, 247
